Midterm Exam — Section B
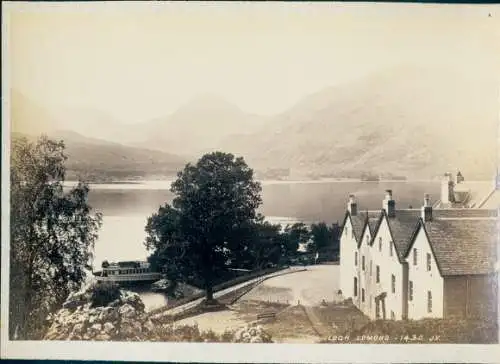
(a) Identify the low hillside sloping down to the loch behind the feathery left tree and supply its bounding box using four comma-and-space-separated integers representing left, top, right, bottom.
7, 92, 187, 181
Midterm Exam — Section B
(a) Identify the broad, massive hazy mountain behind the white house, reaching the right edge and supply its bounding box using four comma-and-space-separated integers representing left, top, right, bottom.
220, 66, 499, 178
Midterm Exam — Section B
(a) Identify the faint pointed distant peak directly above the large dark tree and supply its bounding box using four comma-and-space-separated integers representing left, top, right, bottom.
134, 95, 267, 157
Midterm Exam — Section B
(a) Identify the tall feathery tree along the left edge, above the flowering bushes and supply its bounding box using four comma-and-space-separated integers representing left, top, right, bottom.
9, 137, 101, 339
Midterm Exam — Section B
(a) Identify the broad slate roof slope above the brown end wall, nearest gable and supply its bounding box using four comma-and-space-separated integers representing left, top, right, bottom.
421, 218, 498, 276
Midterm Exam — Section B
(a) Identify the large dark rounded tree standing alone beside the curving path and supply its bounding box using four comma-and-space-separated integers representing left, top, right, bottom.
145, 152, 262, 301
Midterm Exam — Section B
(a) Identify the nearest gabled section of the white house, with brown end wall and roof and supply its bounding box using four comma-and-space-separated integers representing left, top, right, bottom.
406, 210, 498, 319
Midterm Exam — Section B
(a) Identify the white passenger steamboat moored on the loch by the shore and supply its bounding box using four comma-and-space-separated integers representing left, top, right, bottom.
94, 261, 162, 283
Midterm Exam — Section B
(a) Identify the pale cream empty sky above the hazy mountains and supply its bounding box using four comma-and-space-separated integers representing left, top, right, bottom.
2, 2, 500, 123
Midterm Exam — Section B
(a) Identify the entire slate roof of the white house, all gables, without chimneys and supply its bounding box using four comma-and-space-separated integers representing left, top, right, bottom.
344, 208, 499, 276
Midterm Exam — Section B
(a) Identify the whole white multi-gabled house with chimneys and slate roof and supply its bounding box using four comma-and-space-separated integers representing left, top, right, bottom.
340, 190, 498, 320
